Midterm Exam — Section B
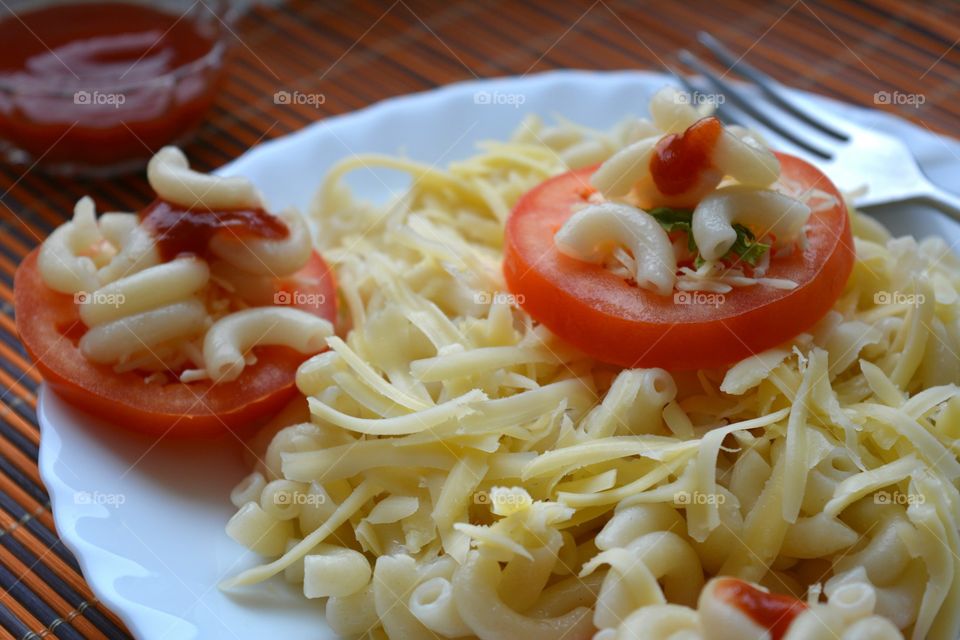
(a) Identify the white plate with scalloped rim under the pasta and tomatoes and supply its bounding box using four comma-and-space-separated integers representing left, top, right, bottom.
38, 71, 960, 640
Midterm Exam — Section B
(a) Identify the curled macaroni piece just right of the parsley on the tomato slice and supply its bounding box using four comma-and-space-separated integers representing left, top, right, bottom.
692, 186, 810, 262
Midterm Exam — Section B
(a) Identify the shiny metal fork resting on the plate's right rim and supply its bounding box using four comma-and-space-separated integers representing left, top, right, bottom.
674, 32, 960, 221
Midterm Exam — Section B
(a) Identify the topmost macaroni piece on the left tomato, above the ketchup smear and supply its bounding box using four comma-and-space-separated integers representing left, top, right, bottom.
147, 147, 261, 209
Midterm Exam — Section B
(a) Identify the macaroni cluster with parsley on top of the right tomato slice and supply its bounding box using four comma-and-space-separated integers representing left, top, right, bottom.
555, 87, 811, 295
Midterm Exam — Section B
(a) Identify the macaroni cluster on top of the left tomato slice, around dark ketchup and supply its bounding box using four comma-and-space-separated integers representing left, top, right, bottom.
38, 147, 333, 382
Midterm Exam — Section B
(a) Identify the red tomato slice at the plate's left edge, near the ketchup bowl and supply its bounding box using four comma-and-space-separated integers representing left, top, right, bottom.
14, 249, 336, 436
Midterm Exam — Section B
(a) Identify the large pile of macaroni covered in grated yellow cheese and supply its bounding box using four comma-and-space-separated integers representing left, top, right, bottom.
223, 93, 960, 640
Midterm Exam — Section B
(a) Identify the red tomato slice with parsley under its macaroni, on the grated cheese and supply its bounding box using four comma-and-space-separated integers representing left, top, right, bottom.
503, 154, 854, 370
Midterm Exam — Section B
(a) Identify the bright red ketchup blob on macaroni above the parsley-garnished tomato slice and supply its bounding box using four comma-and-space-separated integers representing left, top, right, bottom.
650, 117, 722, 196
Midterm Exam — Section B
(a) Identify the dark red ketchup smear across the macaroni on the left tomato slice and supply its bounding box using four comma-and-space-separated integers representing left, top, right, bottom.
140, 200, 290, 261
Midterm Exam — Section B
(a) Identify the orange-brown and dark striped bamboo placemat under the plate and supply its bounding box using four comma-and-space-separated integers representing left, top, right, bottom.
0, 0, 960, 639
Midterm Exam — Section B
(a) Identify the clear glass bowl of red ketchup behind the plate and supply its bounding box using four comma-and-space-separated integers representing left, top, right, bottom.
0, 0, 230, 176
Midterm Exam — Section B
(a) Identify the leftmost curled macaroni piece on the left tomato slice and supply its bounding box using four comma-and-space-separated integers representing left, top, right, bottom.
37, 197, 103, 293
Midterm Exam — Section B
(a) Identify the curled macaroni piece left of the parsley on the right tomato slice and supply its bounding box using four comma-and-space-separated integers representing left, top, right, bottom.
555, 202, 677, 295
